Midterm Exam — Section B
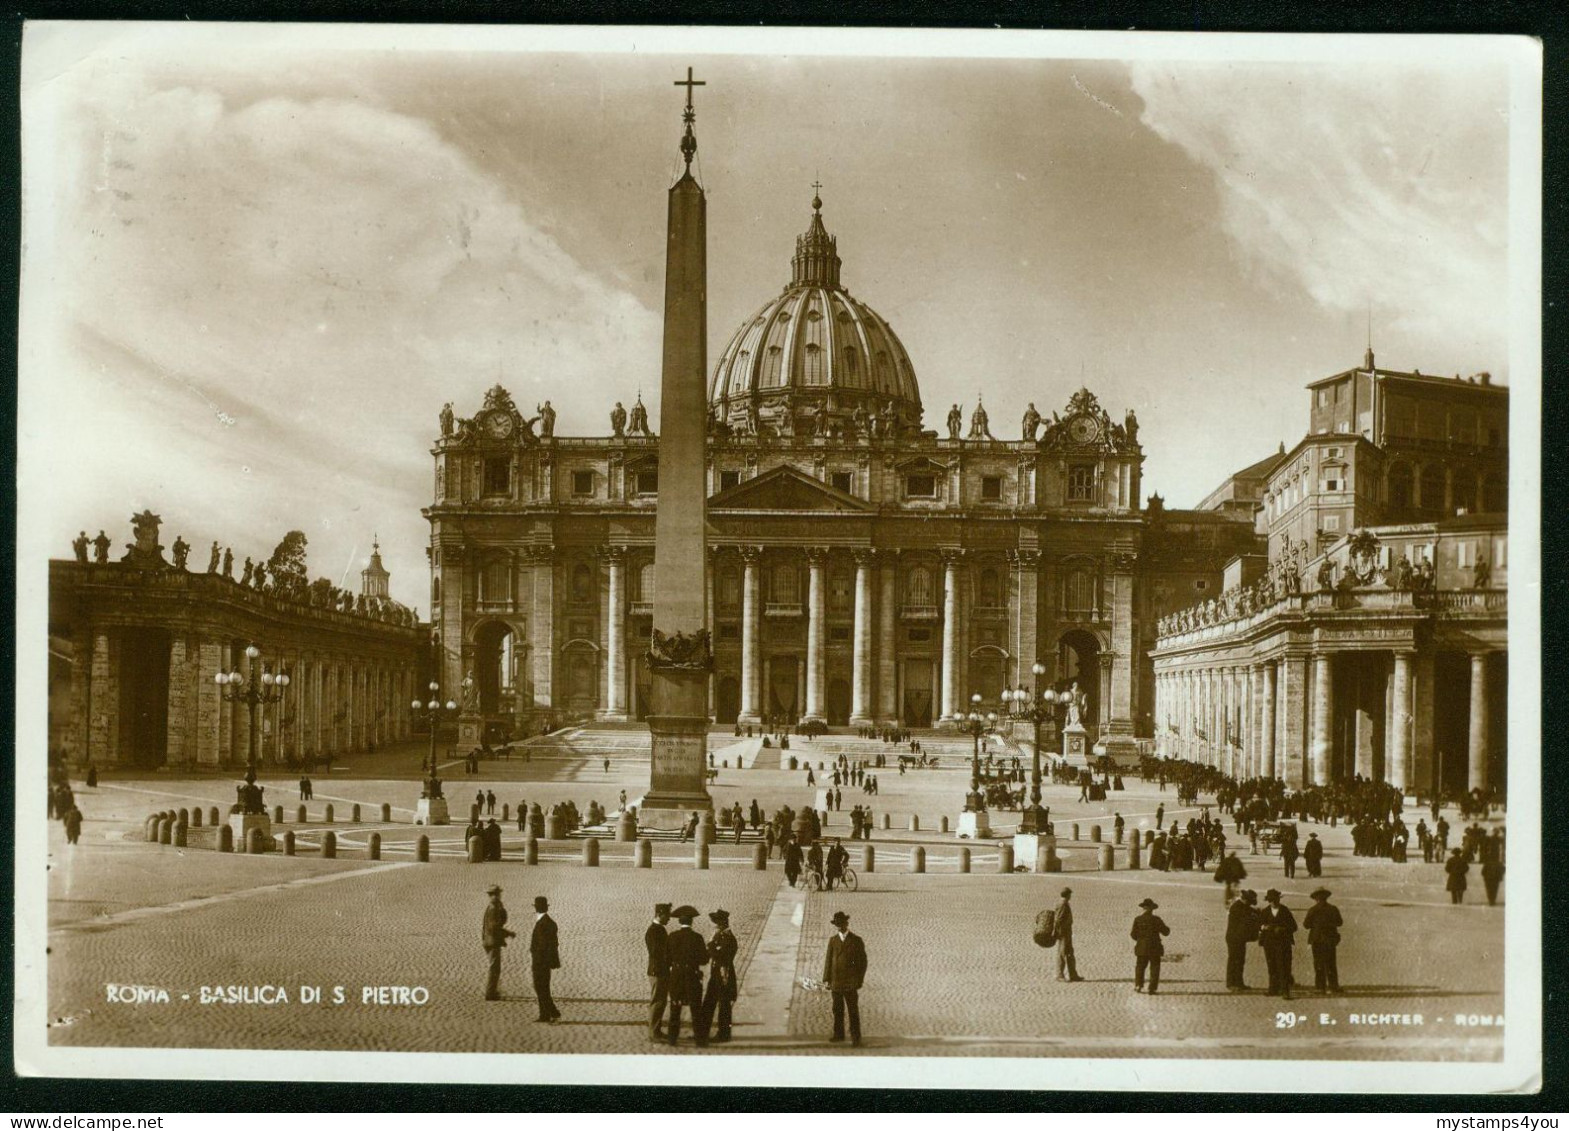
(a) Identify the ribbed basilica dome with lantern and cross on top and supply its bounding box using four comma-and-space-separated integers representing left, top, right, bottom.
709, 196, 921, 435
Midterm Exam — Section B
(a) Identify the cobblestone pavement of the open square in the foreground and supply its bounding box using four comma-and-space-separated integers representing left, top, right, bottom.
47, 730, 1503, 1059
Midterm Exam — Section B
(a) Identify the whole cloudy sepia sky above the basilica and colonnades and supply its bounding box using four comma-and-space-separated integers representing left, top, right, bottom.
19, 24, 1517, 613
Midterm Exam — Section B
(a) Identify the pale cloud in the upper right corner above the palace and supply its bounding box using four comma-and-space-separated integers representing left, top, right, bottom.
1131, 63, 1508, 362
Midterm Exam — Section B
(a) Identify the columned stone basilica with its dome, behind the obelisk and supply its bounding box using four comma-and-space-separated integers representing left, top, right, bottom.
425, 199, 1255, 753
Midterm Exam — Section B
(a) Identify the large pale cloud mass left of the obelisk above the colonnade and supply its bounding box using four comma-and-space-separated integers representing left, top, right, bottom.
24, 61, 659, 607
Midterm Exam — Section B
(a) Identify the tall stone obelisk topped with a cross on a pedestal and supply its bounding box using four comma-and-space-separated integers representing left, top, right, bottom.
639, 67, 714, 827
